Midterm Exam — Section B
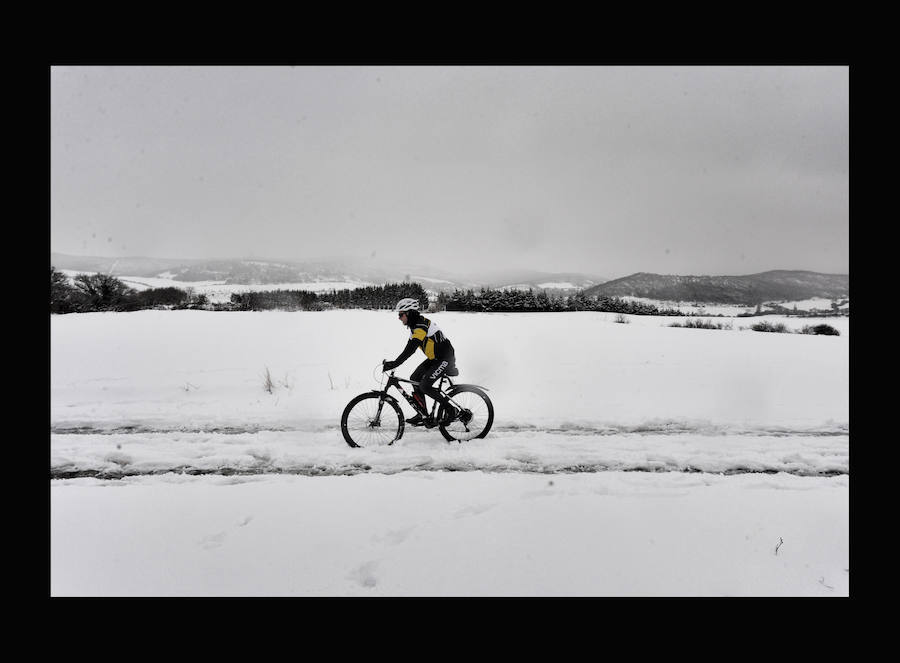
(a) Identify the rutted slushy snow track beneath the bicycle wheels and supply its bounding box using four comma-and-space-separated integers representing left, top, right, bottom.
50, 422, 850, 479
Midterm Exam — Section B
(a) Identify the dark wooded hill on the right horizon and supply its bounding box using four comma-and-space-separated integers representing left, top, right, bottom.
585, 270, 850, 306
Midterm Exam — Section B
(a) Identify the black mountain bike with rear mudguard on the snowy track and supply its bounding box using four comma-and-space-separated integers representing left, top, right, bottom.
341, 364, 494, 448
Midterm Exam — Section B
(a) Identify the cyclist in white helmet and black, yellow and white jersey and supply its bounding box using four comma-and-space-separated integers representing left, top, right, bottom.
382, 297, 459, 428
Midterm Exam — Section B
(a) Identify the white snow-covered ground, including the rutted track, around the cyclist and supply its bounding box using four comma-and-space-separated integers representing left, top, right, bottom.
50, 310, 849, 596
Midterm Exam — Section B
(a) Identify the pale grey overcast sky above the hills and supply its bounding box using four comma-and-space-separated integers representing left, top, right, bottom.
50, 66, 850, 278
